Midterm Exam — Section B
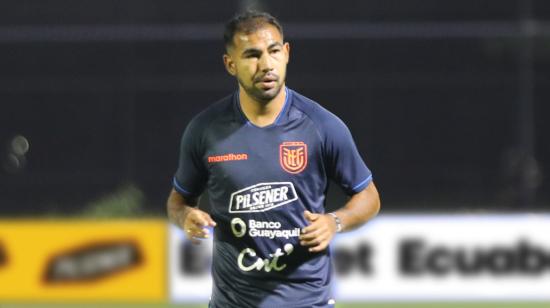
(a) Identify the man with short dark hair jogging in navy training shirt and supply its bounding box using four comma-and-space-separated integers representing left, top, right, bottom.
167, 12, 380, 308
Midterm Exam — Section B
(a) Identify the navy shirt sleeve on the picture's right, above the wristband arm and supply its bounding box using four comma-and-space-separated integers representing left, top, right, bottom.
325, 116, 372, 195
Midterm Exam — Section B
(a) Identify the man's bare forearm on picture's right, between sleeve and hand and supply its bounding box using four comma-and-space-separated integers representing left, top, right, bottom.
334, 182, 380, 231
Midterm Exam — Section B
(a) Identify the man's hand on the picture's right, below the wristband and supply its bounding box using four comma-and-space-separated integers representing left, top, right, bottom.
300, 211, 336, 252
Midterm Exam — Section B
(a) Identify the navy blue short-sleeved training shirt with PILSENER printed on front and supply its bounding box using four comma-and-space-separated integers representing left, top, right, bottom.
174, 88, 372, 308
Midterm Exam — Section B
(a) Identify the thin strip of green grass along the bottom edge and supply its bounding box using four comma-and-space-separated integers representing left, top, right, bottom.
0, 302, 550, 308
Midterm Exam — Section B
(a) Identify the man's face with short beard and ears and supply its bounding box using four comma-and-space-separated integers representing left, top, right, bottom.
223, 24, 290, 103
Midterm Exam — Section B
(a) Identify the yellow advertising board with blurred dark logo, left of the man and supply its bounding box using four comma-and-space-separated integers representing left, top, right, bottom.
0, 220, 167, 302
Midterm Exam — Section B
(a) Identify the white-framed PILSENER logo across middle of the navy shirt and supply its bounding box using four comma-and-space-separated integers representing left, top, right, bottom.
229, 182, 298, 213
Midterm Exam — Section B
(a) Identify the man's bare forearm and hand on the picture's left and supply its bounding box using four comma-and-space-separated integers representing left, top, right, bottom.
166, 189, 216, 244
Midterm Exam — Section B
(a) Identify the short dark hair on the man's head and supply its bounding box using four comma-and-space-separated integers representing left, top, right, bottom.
223, 10, 283, 50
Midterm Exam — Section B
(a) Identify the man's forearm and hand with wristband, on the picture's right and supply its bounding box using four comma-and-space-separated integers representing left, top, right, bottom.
300, 182, 380, 252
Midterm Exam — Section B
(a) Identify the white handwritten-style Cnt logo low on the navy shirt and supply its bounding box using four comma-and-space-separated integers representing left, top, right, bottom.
237, 243, 294, 273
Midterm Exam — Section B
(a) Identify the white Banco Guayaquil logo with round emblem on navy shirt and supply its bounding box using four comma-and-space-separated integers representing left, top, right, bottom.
231, 217, 300, 239
